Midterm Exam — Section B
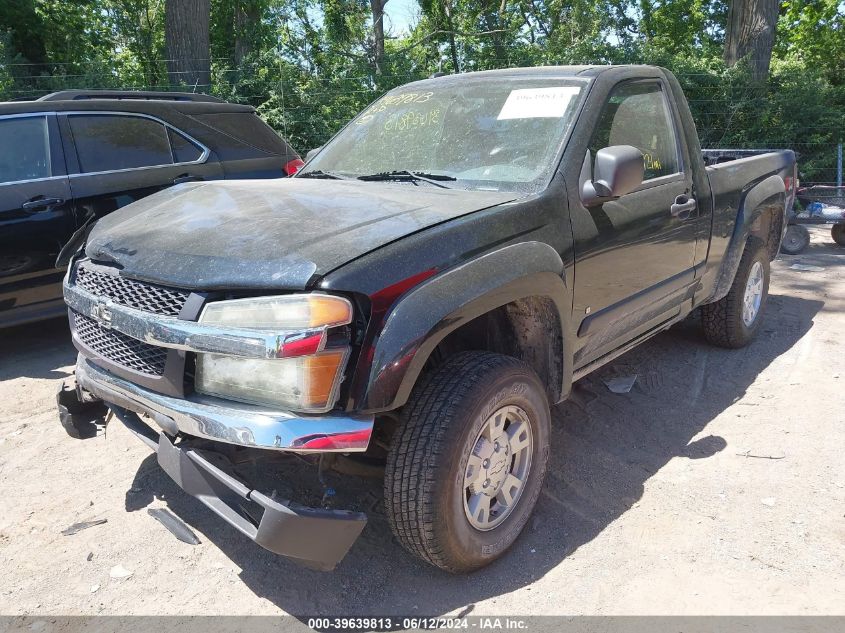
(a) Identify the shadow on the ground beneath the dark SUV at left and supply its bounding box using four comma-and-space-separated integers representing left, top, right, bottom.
0, 317, 76, 381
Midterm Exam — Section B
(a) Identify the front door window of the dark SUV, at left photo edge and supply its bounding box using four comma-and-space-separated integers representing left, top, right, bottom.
0, 116, 51, 183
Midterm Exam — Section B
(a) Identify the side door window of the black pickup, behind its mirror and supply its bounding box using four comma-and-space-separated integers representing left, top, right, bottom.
590, 82, 681, 180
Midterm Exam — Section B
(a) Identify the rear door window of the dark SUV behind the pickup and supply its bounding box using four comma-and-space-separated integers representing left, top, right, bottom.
68, 114, 173, 173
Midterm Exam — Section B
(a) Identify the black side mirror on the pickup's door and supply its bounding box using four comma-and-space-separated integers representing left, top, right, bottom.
581, 145, 645, 204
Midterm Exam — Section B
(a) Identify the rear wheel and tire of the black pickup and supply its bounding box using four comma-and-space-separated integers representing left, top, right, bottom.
701, 237, 769, 349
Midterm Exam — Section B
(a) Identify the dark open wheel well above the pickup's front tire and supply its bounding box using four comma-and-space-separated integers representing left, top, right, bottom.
425, 296, 563, 403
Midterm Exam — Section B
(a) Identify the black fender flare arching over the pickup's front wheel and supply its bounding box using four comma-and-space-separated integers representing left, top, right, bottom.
362, 242, 572, 412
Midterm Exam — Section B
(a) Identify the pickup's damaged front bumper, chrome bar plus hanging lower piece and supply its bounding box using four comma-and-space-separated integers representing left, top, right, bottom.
69, 355, 373, 570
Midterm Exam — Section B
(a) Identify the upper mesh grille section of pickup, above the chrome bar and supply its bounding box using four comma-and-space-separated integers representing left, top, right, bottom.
76, 262, 191, 316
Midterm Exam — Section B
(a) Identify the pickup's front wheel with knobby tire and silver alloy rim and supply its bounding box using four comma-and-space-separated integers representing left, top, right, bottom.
384, 352, 551, 573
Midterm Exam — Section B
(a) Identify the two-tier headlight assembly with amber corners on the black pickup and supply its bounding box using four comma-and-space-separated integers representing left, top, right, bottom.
195, 294, 352, 413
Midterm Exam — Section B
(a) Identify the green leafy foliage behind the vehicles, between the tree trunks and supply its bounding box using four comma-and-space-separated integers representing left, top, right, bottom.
0, 0, 845, 181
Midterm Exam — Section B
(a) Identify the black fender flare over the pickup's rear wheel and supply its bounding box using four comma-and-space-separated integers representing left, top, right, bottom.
708, 175, 786, 303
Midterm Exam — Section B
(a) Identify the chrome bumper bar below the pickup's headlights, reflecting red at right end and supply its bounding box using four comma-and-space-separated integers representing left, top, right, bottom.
76, 355, 373, 453
